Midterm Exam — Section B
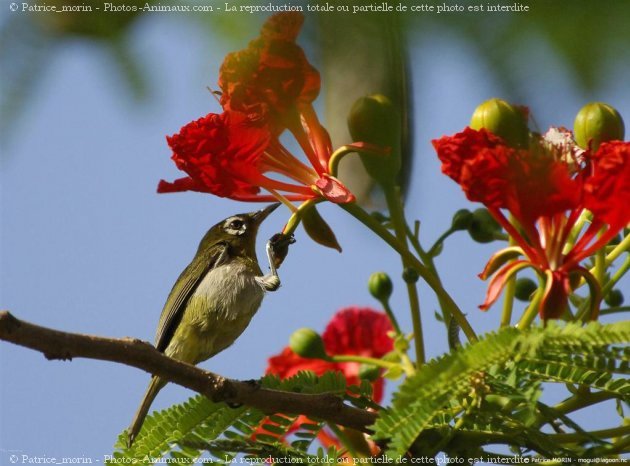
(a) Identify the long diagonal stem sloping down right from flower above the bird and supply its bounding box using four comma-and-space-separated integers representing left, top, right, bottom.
339, 202, 477, 341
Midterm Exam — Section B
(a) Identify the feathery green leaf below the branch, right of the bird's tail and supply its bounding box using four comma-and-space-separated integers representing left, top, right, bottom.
112, 372, 350, 464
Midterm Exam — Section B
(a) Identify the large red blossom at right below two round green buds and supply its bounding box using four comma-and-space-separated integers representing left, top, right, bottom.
433, 128, 630, 319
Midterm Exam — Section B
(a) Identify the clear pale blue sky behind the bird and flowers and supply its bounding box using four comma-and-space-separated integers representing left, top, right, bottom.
0, 6, 630, 462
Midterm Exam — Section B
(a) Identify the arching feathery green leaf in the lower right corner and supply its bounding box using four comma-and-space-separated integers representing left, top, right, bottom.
373, 322, 630, 457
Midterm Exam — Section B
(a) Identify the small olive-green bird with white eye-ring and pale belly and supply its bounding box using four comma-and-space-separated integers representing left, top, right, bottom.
127, 204, 294, 446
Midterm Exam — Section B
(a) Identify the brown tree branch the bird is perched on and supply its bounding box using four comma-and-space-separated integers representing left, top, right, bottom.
0, 311, 376, 433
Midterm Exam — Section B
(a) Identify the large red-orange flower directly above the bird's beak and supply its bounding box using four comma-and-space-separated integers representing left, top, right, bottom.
158, 13, 354, 204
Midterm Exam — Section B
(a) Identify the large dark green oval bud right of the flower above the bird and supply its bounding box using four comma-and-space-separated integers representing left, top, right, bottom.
348, 94, 401, 185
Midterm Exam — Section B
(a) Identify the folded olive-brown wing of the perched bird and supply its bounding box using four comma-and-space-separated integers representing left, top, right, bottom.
155, 243, 228, 352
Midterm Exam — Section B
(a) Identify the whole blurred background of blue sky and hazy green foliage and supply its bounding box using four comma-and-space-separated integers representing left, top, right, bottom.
0, 0, 630, 458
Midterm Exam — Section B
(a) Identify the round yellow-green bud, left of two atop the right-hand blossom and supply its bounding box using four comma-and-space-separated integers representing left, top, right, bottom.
470, 99, 529, 147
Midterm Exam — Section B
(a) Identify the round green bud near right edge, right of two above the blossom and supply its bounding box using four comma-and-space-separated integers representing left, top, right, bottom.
573, 102, 625, 151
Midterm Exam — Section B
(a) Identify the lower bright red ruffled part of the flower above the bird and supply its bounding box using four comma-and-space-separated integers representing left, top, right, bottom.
158, 111, 354, 203
